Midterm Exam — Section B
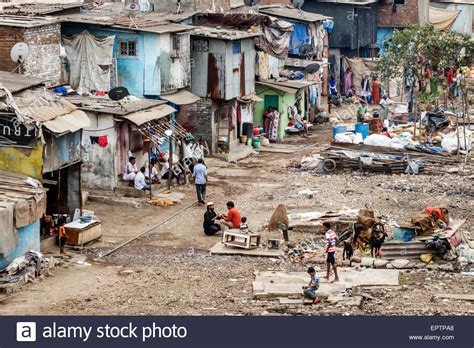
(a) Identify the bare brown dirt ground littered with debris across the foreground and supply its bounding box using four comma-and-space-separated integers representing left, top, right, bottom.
0, 127, 474, 315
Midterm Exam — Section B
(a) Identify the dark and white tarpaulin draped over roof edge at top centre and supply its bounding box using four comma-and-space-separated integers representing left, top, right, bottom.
194, 13, 293, 58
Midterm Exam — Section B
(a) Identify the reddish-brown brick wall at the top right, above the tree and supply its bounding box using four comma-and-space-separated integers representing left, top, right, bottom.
378, 0, 418, 28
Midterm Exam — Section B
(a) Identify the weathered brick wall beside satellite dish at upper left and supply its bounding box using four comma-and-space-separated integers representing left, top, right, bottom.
24, 24, 61, 85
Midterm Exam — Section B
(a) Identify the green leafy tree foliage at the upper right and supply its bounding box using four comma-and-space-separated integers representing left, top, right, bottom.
377, 24, 474, 80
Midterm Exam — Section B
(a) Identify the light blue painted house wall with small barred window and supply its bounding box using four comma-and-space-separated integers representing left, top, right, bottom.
62, 23, 161, 97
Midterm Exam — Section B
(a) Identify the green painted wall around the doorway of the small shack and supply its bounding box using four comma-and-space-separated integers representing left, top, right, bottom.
254, 84, 305, 139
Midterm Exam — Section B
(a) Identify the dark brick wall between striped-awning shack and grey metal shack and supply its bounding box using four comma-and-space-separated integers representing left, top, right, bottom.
176, 98, 215, 153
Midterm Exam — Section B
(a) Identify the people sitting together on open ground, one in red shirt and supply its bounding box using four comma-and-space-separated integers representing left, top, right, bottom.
202, 201, 249, 236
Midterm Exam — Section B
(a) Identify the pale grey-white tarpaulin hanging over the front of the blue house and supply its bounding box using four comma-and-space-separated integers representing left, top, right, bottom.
62, 30, 115, 92
